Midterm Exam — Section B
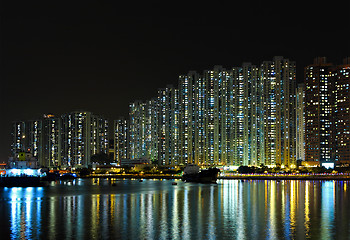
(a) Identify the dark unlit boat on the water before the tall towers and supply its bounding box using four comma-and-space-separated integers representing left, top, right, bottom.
182, 164, 220, 183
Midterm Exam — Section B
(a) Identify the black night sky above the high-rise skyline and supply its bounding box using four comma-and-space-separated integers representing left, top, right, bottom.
0, 1, 350, 162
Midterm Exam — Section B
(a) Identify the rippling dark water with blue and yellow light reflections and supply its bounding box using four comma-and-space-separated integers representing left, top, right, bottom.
0, 179, 350, 239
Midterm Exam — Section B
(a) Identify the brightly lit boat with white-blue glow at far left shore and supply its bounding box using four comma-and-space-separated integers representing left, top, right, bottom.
0, 152, 46, 187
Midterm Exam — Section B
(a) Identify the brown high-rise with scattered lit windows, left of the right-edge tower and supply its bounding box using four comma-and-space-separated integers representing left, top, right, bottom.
305, 58, 335, 164
